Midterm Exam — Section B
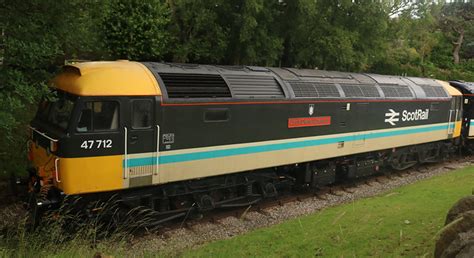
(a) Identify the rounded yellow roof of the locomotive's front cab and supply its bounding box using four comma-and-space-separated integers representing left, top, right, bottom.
53, 60, 161, 96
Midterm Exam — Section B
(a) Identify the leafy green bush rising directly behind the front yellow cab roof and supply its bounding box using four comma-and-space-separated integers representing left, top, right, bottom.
102, 0, 170, 60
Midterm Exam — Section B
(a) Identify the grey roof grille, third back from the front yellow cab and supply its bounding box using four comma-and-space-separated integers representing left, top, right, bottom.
290, 82, 341, 98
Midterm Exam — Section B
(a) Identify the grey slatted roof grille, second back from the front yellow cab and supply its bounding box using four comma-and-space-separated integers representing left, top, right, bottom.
225, 75, 285, 98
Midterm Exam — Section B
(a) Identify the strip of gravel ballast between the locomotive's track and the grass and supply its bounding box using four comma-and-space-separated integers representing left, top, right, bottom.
129, 158, 474, 256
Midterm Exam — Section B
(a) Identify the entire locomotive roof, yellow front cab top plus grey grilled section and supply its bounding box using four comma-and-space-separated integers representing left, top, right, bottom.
53, 61, 460, 100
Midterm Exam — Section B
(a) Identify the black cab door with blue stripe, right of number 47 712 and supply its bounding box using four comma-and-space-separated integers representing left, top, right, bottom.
124, 98, 159, 187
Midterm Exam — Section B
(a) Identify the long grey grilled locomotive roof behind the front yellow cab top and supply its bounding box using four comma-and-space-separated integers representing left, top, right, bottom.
143, 62, 460, 100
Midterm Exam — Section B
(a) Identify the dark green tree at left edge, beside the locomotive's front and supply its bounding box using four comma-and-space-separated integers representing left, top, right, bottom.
0, 0, 105, 173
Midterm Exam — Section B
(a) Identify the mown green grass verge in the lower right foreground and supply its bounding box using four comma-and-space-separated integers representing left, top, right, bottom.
184, 167, 474, 257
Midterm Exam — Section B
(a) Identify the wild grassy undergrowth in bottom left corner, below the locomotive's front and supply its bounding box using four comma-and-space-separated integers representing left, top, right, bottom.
0, 196, 147, 257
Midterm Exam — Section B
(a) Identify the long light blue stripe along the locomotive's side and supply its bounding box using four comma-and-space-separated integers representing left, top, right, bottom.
123, 125, 448, 167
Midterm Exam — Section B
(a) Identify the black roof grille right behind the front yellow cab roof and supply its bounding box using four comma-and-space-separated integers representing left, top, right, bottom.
159, 73, 232, 98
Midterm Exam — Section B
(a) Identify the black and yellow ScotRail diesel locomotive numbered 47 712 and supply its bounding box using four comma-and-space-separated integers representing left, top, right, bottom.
25, 61, 462, 224
